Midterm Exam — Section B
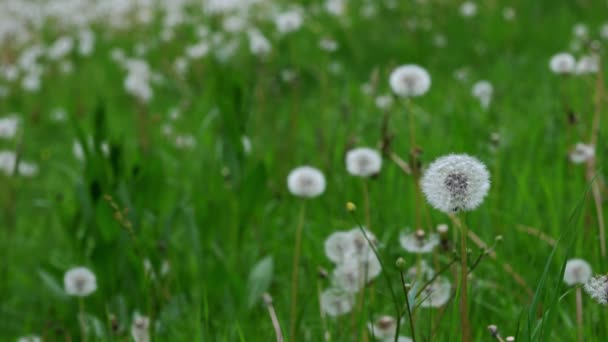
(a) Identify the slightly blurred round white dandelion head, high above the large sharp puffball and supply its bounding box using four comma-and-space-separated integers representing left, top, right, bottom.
389, 64, 431, 97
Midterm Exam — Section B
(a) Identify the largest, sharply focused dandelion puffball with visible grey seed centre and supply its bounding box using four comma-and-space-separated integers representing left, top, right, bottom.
420, 154, 490, 214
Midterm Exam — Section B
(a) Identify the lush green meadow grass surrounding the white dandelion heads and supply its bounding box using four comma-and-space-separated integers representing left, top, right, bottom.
0, 1, 608, 341
